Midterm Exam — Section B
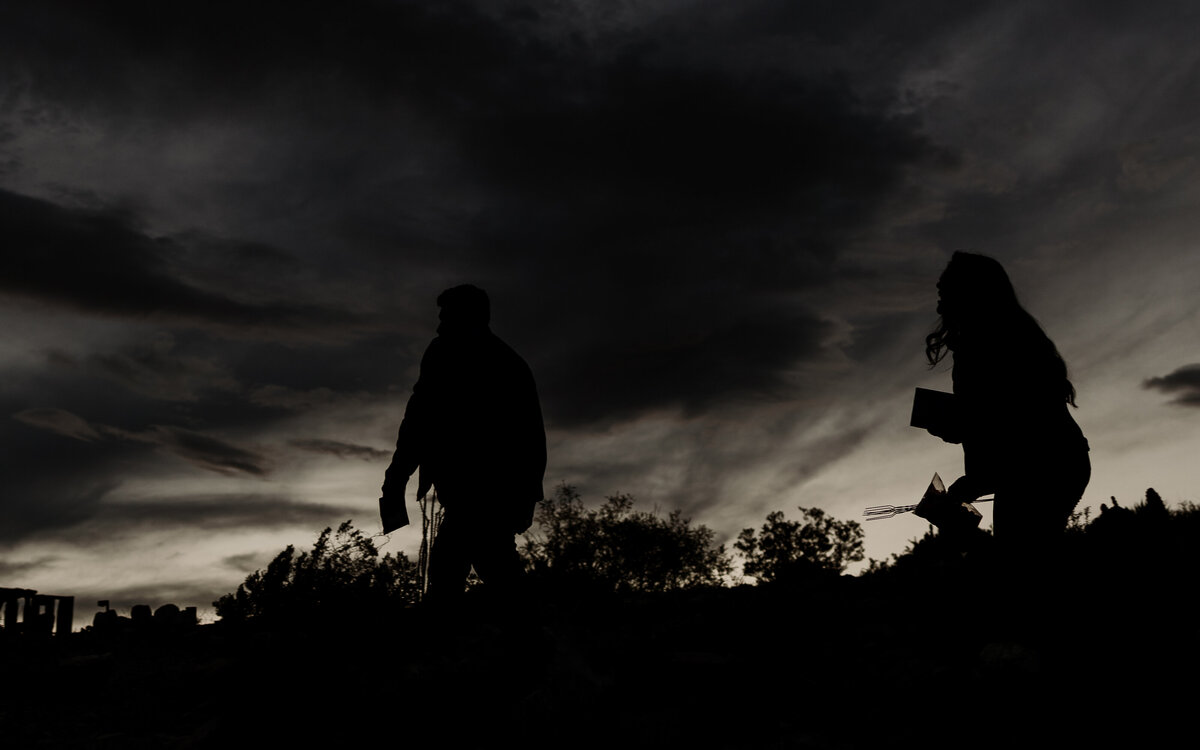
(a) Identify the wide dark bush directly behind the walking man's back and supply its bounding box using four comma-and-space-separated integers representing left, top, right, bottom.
522, 485, 733, 592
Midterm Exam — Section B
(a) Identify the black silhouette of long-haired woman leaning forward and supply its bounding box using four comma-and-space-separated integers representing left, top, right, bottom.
925, 252, 1091, 549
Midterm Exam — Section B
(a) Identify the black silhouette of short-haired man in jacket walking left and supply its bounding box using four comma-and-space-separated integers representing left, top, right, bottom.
382, 284, 546, 601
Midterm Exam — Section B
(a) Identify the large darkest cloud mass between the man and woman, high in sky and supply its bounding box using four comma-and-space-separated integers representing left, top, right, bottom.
360, 16, 935, 427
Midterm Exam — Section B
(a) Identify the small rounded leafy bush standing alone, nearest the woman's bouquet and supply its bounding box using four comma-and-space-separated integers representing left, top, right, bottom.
733, 508, 863, 583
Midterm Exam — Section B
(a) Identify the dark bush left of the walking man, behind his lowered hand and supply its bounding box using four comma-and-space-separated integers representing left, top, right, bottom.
212, 521, 420, 623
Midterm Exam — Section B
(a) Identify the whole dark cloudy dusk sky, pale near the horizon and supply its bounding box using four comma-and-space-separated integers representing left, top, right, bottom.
0, 0, 1200, 617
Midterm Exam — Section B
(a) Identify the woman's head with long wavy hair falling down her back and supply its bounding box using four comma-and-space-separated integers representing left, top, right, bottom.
925, 252, 1076, 406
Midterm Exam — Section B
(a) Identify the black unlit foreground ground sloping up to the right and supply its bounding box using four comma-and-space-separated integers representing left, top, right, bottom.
0, 553, 1200, 748
